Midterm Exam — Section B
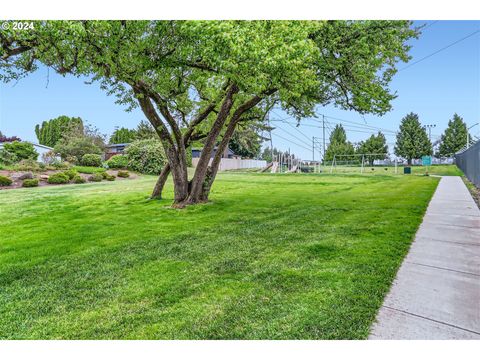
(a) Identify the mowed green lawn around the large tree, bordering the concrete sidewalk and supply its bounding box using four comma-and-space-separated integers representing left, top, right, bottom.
0, 173, 438, 339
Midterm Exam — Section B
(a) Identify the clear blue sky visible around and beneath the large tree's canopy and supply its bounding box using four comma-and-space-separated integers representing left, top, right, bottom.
0, 21, 480, 159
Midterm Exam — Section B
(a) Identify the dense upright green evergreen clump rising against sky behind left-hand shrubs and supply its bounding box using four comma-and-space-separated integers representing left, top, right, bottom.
35, 115, 83, 147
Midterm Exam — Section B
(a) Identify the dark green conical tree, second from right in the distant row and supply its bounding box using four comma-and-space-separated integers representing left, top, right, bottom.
395, 112, 433, 165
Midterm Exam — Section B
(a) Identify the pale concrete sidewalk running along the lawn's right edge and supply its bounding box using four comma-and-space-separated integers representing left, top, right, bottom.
369, 176, 480, 339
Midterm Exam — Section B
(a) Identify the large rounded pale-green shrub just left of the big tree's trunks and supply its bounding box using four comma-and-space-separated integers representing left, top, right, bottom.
125, 139, 167, 175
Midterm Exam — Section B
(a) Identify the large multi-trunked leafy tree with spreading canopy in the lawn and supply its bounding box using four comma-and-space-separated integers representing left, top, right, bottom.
0, 21, 417, 207
